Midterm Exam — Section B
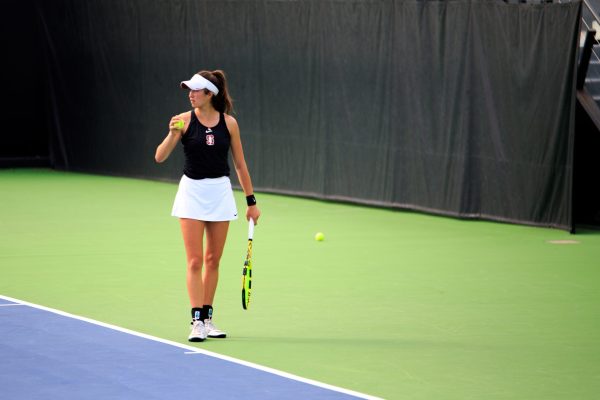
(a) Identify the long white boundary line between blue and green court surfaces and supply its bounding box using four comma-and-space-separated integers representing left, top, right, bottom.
0, 295, 383, 400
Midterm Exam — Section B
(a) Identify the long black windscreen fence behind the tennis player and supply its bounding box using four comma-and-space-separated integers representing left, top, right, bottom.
36, 0, 581, 229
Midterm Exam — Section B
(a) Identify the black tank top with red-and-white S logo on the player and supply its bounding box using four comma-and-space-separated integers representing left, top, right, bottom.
181, 110, 231, 179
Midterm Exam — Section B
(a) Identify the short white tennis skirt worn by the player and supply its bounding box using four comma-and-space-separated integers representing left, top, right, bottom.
171, 175, 237, 221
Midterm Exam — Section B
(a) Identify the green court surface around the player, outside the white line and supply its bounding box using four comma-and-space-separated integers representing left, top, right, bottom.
0, 170, 600, 399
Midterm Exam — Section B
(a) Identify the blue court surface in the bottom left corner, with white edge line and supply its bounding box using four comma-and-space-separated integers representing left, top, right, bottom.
0, 296, 374, 400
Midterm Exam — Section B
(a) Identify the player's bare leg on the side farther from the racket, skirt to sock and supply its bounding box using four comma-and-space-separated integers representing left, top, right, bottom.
179, 218, 206, 308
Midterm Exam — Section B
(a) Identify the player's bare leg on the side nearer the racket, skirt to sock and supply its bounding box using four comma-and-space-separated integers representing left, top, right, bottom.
202, 221, 229, 305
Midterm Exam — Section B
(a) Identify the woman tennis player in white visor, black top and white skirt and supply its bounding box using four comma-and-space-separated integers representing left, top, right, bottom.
155, 70, 260, 342
